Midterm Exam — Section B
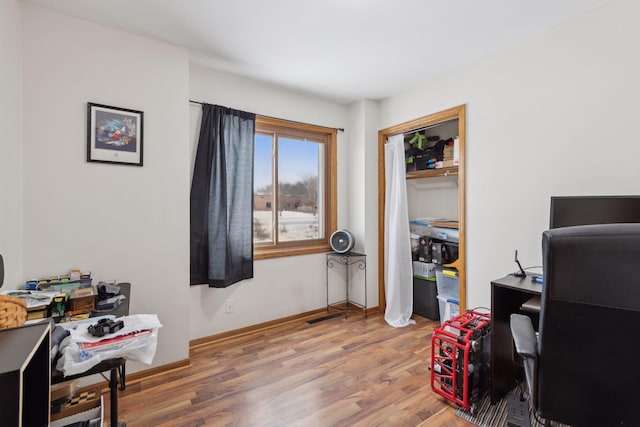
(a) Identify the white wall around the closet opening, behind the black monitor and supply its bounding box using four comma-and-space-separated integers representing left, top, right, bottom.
381, 0, 640, 307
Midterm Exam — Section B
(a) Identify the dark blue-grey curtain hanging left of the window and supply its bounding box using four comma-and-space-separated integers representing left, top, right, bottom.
191, 104, 255, 288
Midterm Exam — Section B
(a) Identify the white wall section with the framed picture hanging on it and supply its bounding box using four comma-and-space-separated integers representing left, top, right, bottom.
23, 5, 191, 370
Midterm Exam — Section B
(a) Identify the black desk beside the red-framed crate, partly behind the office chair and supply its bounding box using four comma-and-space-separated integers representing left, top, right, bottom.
490, 275, 542, 404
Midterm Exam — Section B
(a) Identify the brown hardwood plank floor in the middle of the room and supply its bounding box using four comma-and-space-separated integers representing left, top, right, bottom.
105, 315, 472, 427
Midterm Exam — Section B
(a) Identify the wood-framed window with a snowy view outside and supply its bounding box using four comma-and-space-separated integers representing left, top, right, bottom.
253, 116, 336, 259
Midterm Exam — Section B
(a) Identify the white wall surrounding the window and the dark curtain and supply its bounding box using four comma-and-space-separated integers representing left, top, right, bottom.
189, 64, 349, 339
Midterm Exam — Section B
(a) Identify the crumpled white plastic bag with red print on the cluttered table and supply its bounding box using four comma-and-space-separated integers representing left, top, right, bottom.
56, 314, 162, 376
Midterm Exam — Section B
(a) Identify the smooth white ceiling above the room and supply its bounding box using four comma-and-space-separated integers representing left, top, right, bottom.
23, 0, 612, 104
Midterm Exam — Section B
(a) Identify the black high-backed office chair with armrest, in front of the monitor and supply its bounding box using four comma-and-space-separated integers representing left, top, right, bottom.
511, 224, 640, 426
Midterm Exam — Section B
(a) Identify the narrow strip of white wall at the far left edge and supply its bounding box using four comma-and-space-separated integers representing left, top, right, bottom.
0, 0, 22, 289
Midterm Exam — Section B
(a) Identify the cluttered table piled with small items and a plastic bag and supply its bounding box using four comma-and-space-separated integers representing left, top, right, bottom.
0, 270, 162, 427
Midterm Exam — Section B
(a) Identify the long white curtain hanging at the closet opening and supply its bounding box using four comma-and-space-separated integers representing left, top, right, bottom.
384, 134, 416, 328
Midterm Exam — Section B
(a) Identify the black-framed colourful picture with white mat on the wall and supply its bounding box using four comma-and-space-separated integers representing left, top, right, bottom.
87, 102, 144, 166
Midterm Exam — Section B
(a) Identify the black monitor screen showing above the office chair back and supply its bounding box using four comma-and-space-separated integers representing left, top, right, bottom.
549, 196, 640, 228
